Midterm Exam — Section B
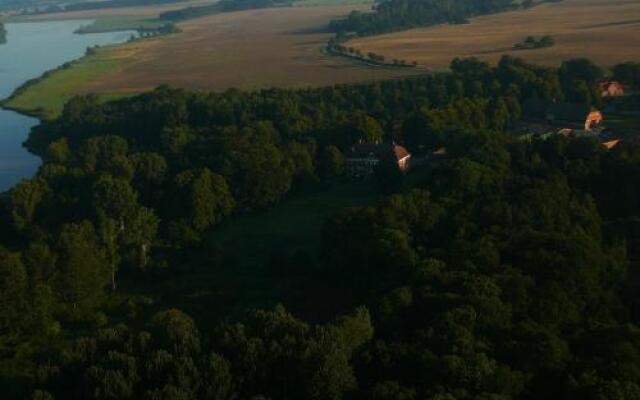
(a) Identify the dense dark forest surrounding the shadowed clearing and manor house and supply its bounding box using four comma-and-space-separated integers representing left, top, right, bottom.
0, 57, 640, 400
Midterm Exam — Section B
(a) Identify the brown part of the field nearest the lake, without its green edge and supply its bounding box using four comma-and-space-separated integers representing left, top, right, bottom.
86, 6, 420, 92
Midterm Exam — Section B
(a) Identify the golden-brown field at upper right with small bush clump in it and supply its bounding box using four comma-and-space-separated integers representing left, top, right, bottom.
348, 0, 640, 68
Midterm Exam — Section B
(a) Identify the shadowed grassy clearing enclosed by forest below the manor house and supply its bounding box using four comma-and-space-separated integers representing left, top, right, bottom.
120, 181, 378, 325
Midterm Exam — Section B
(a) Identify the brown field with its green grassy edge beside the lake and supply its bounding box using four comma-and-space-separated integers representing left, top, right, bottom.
8, 5, 417, 116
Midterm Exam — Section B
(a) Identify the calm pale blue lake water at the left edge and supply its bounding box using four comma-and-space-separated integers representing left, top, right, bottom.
0, 20, 132, 192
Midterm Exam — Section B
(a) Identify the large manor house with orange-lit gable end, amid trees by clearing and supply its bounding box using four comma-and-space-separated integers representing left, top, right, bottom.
345, 143, 411, 177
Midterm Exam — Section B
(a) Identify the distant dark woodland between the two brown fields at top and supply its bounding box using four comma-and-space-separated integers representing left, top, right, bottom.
330, 0, 555, 36
